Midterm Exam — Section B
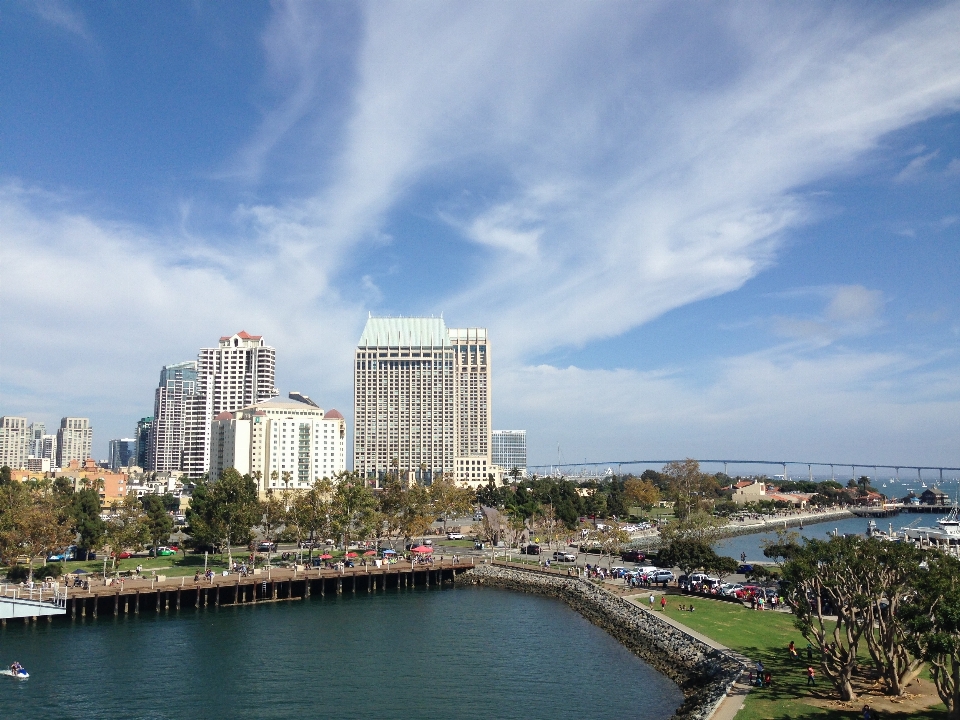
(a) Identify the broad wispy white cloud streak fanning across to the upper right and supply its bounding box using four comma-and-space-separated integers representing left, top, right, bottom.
306, 4, 960, 357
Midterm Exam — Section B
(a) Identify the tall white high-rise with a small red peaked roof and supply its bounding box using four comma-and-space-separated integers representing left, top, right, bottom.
180, 330, 279, 478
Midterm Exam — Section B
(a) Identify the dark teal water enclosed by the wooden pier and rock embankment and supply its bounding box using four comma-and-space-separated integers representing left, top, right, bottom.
0, 587, 683, 720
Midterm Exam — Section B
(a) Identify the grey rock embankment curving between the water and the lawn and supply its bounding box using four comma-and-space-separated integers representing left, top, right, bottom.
456, 565, 744, 720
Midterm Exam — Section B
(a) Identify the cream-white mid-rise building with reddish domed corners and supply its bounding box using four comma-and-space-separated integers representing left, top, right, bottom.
210, 393, 347, 496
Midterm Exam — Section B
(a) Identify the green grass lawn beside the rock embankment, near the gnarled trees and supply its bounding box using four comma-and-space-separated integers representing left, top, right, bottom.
667, 595, 946, 720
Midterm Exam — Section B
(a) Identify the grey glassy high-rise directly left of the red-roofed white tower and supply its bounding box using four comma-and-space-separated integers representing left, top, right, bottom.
149, 360, 202, 472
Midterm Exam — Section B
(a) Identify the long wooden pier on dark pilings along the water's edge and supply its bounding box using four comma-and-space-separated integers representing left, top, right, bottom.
54, 558, 473, 619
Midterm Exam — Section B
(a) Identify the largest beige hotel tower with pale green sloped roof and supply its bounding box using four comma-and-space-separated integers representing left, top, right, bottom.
353, 317, 492, 482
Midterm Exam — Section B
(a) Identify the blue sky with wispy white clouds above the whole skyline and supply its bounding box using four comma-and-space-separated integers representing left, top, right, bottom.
0, 0, 960, 466
